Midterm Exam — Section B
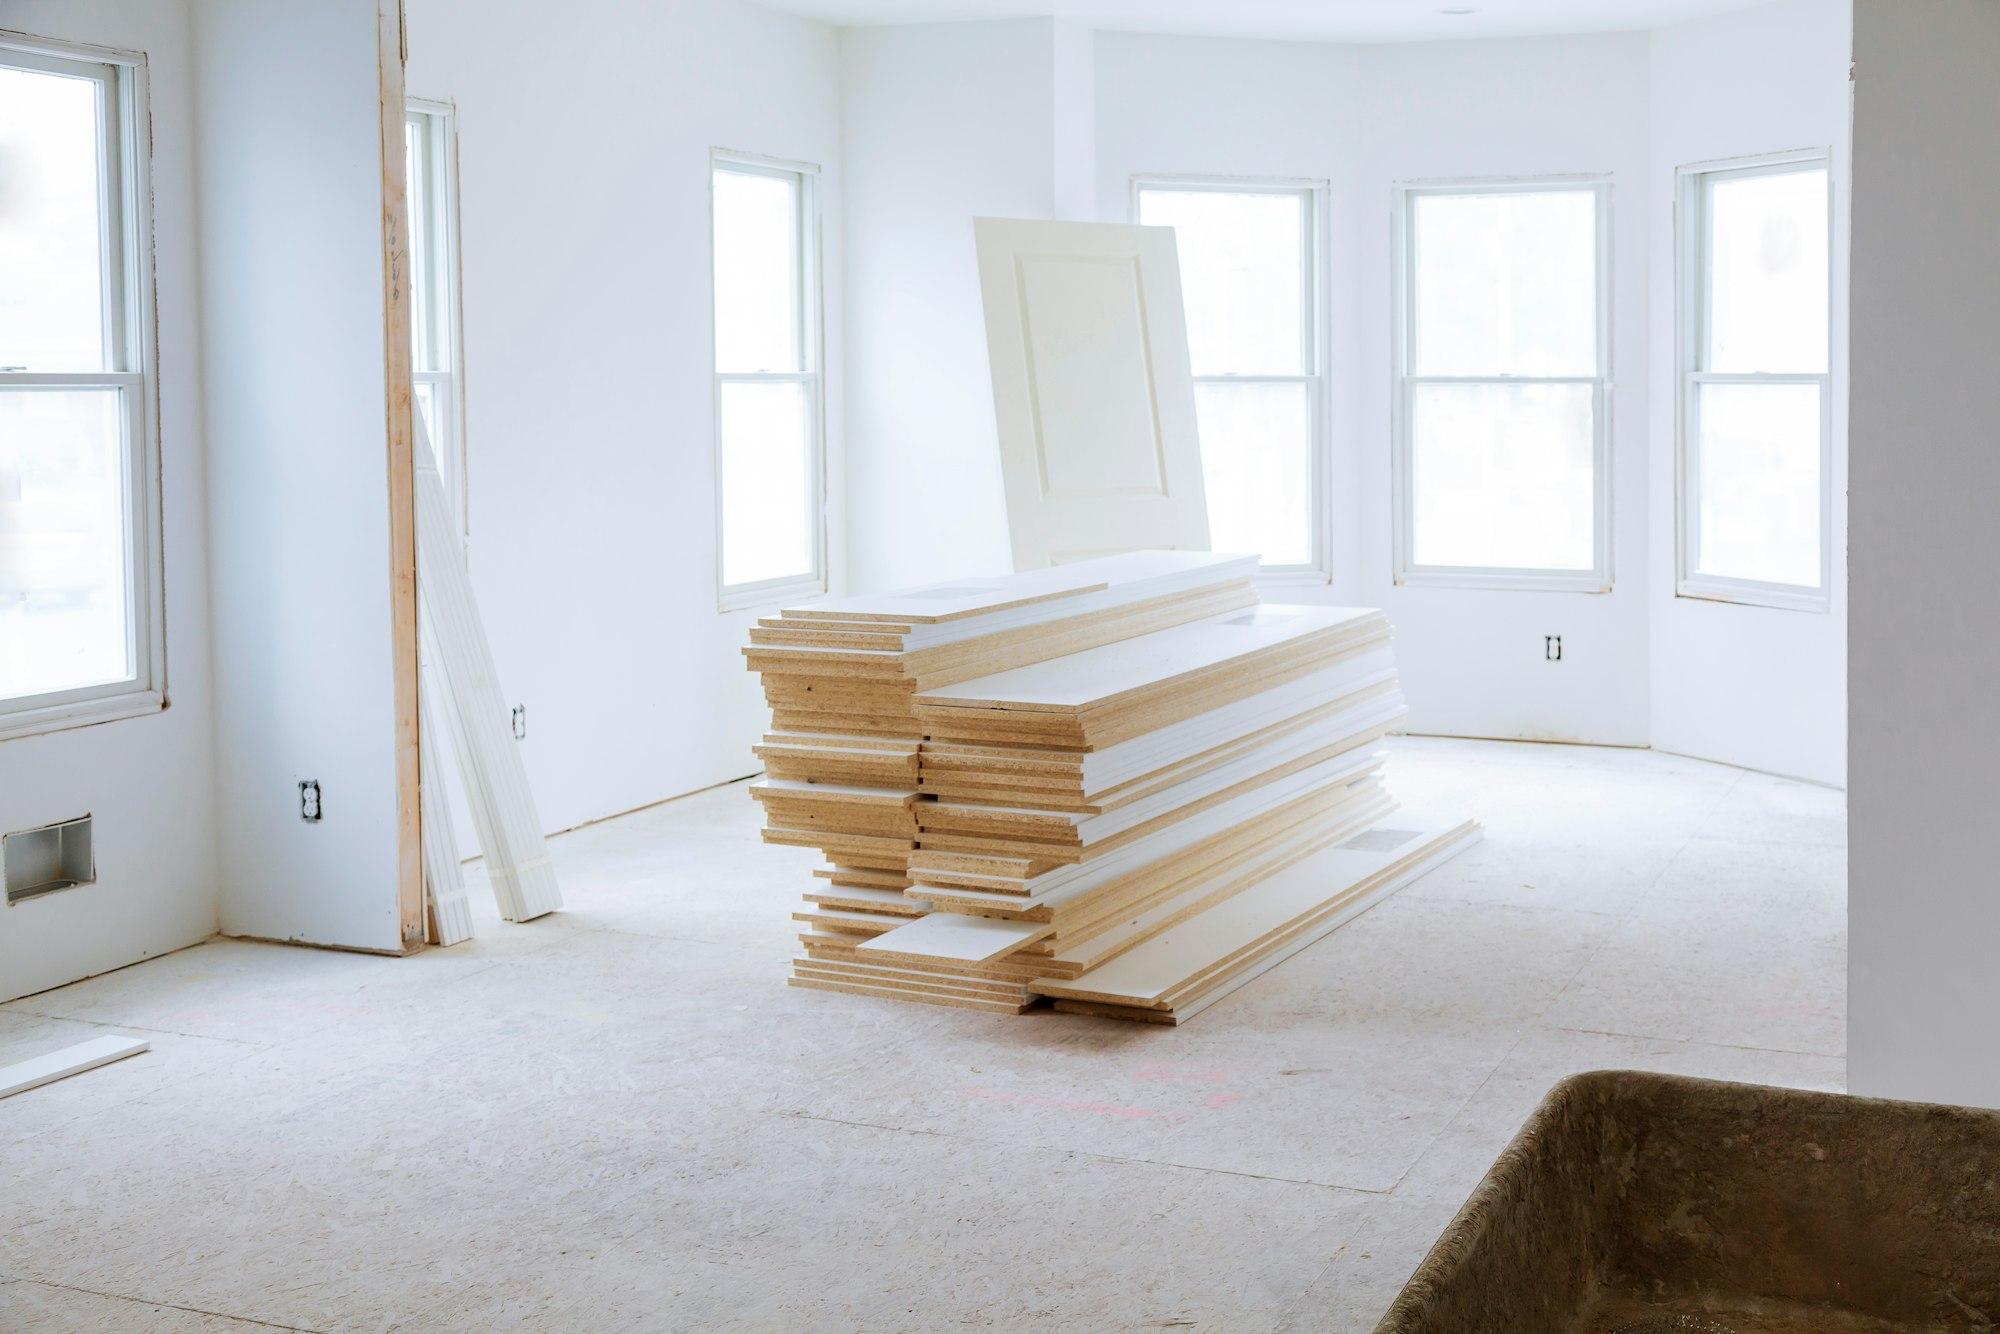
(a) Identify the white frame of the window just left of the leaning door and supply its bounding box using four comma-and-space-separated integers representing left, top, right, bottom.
708, 148, 826, 612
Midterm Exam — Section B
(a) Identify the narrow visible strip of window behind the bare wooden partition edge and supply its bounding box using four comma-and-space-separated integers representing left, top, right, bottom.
402, 98, 470, 534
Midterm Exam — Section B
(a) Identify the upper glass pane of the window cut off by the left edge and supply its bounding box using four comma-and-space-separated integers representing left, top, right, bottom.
0, 66, 112, 370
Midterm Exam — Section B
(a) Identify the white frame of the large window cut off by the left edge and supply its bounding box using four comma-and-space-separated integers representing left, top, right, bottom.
0, 32, 168, 740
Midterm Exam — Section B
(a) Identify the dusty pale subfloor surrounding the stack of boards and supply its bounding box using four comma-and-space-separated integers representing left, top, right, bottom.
0, 740, 1846, 1330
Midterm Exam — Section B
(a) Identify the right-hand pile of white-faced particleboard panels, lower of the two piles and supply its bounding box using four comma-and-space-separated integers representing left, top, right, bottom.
820, 606, 1448, 1008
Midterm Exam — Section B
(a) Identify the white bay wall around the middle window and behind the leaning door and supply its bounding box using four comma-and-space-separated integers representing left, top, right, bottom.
1096, 32, 1656, 744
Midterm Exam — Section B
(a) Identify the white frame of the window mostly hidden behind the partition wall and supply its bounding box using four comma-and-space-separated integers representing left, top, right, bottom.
404, 98, 472, 540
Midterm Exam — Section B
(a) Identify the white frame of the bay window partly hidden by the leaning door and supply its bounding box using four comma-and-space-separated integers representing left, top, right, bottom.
1130, 172, 1334, 586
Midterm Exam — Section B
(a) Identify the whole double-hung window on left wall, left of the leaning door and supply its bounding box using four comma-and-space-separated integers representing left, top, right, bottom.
712, 152, 826, 610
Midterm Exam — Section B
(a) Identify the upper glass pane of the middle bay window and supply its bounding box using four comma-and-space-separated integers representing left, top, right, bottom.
1410, 190, 1598, 376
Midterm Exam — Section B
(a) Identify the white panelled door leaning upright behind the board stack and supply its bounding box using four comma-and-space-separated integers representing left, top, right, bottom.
974, 218, 1208, 570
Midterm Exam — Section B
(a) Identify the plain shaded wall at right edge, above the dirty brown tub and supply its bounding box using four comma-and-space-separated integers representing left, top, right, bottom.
1848, 0, 2000, 1106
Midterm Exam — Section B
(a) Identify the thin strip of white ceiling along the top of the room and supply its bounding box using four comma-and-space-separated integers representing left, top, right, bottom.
764, 0, 1760, 42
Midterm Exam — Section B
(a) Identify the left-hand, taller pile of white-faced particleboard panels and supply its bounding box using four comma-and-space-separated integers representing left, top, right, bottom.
744, 552, 1256, 990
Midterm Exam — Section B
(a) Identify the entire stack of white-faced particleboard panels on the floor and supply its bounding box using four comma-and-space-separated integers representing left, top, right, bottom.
744, 552, 1478, 1024
